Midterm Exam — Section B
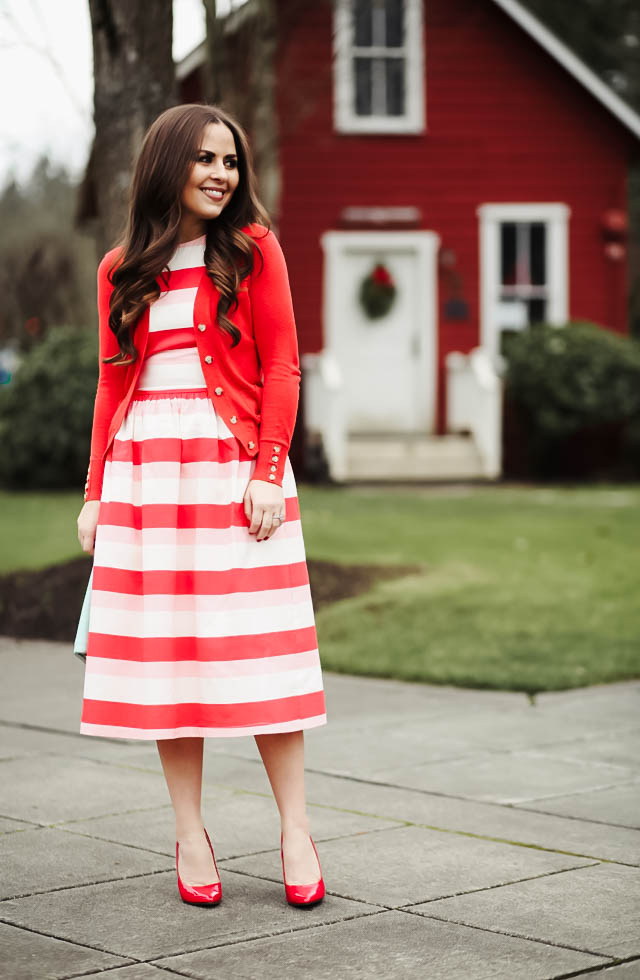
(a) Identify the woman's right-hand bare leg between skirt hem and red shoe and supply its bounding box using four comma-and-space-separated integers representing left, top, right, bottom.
254, 731, 320, 885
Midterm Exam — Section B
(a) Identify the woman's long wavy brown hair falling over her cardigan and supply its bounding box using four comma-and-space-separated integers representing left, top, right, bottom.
104, 103, 270, 364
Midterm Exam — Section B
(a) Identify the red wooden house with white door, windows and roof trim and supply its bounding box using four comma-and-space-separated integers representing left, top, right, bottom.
178, 0, 640, 480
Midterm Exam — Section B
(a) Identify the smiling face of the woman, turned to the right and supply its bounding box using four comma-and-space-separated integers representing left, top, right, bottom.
180, 123, 240, 241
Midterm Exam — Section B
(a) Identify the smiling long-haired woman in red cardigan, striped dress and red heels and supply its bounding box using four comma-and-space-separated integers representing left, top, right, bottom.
78, 104, 326, 905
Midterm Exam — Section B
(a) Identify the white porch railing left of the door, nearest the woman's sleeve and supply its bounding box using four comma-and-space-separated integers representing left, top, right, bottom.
300, 350, 347, 481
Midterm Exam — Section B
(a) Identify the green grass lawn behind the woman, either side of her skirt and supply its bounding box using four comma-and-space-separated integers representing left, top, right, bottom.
0, 485, 640, 692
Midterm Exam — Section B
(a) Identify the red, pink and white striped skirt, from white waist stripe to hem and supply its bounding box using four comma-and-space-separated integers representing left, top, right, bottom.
80, 348, 326, 739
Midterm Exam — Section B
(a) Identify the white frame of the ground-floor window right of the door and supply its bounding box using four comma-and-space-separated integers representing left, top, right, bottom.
477, 203, 571, 358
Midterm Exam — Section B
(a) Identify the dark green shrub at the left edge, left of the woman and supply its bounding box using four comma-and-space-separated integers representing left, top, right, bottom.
0, 327, 98, 490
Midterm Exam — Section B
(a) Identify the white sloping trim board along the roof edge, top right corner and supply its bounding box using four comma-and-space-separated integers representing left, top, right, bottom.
493, 0, 640, 139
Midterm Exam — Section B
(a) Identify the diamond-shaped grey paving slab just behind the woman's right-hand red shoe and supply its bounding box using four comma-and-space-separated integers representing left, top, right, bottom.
225, 827, 589, 906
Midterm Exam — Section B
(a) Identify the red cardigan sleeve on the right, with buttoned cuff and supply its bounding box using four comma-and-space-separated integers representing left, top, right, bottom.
249, 229, 300, 486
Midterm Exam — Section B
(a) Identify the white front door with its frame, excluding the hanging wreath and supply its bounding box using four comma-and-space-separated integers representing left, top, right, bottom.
322, 231, 439, 434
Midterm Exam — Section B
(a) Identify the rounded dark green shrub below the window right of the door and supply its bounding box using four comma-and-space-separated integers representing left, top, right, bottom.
505, 322, 640, 476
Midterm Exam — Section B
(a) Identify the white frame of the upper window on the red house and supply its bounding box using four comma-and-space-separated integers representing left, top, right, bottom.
333, 0, 425, 133
